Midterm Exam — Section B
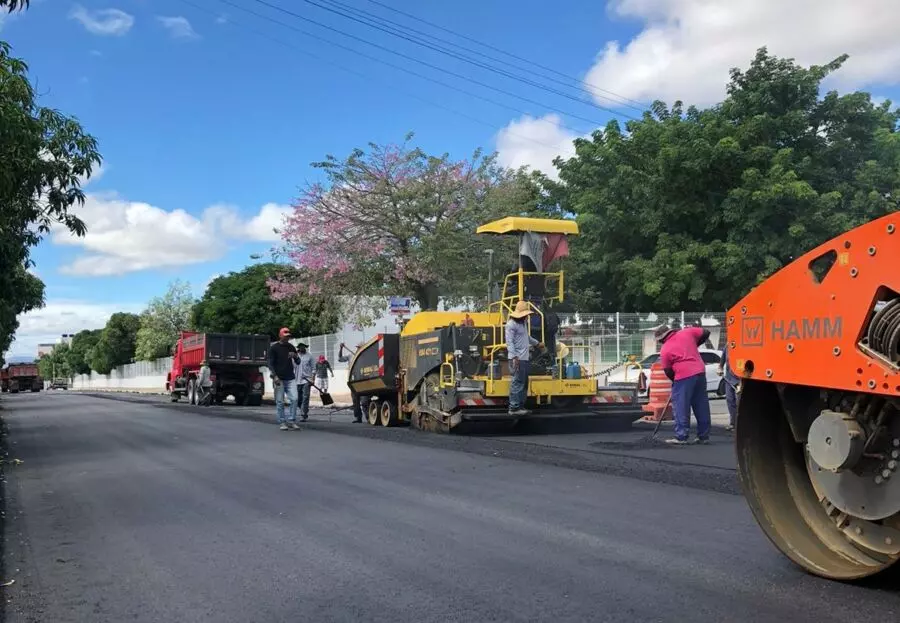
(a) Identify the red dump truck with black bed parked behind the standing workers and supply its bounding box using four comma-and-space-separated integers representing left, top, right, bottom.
166, 331, 269, 407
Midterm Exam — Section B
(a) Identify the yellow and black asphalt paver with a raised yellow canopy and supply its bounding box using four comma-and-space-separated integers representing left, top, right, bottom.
348, 217, 642, 432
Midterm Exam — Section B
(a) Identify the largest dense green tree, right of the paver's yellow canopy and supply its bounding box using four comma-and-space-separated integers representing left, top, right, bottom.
545, 49, 900, 311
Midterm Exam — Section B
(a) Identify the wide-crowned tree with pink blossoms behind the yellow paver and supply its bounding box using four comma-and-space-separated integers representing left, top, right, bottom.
270, 135, 540, 330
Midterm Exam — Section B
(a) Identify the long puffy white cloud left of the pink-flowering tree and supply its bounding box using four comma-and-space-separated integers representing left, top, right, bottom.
52, 193, 290, 276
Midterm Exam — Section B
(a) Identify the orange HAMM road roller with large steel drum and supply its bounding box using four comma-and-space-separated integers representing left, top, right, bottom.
726, 214, 900, 580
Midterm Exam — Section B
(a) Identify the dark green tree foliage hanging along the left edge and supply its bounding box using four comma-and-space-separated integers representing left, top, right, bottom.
0, 6, 100, 360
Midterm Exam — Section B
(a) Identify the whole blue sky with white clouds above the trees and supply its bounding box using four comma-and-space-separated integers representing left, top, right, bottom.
0, 0, 900, 354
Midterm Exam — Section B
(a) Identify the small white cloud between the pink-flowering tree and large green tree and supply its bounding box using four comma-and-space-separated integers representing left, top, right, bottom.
496, 114, 577, 179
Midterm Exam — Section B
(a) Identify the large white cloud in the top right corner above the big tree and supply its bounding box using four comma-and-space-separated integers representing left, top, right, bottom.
585, 0, 900, 105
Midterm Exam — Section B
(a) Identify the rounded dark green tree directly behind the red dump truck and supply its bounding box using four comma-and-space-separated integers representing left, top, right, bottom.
193, 263, 338, 340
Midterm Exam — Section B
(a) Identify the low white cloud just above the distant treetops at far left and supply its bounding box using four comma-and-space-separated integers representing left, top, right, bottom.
9, 299, 144, 357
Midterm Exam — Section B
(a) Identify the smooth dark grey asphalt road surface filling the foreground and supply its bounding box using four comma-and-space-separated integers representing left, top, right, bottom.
0, 393, 900, 623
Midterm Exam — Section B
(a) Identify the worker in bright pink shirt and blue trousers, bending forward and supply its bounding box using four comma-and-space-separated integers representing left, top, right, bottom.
655, 325, 711, 445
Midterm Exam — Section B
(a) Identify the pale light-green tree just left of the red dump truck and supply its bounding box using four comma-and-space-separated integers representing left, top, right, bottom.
135, 280, 194, 361
